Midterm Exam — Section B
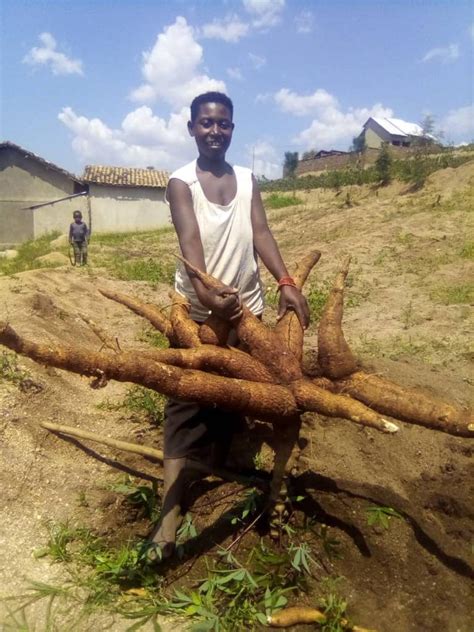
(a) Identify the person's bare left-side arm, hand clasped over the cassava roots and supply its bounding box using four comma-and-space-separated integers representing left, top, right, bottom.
167, 178, 242, 320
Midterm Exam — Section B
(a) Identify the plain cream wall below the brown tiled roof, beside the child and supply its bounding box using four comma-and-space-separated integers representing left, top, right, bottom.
89, 183, 171, 233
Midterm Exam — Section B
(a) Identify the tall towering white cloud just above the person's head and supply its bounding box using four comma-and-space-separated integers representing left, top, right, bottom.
131, 16, 226, 109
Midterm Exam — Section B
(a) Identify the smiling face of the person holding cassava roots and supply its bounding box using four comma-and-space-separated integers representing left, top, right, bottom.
188, 103, 234, 160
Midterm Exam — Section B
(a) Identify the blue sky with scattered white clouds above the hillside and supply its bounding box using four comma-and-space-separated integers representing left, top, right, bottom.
0, 0, 474, 178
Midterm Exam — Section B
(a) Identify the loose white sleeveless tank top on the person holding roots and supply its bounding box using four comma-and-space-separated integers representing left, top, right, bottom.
170, 160, 263, 322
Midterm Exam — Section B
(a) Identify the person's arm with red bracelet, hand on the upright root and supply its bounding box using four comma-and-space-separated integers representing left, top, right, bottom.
251, 177, 309, 329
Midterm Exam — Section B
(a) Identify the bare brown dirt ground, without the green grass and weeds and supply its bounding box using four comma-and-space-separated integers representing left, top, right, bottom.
0, 163, 474, 632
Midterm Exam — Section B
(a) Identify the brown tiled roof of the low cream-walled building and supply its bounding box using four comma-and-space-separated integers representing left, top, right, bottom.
82, 165, 169, 189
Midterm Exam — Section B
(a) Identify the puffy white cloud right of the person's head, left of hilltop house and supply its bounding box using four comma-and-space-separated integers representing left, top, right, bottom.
274, 88, 393, 149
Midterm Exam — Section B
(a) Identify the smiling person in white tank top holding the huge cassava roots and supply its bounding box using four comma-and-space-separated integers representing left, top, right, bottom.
150, 92, 309, 558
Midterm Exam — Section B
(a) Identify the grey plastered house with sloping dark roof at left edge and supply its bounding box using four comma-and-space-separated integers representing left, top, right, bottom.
0, 141, 88, 244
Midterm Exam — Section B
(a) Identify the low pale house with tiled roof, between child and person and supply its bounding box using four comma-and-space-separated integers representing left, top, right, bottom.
82, 165, 170, 232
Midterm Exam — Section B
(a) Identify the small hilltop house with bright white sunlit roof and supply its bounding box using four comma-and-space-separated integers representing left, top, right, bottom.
359, 117, 434, 149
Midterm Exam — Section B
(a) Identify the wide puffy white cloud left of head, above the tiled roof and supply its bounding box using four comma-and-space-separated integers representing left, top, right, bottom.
58, 106, 195, 170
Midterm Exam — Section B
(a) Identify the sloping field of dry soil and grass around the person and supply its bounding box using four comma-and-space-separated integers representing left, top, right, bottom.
0, 162, 474, 632
